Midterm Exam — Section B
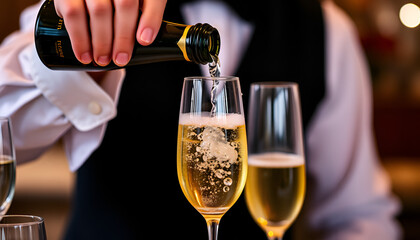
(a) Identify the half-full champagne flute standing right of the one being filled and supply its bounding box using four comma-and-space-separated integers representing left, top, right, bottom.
245, 82, 305, 240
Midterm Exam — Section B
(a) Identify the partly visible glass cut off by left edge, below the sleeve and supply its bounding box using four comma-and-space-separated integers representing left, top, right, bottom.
0, 117, 16, 216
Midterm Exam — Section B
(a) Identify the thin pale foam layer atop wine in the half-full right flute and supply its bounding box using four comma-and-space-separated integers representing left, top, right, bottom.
248, 152, 305, 168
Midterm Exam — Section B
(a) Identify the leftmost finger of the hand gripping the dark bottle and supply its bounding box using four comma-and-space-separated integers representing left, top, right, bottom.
55, 0, 92, 64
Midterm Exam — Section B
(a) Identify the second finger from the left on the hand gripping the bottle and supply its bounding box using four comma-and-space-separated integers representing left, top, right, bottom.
86, 0, 113, 66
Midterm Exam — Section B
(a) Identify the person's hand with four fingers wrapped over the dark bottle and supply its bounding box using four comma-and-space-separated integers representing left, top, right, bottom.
55, 0, 166, 66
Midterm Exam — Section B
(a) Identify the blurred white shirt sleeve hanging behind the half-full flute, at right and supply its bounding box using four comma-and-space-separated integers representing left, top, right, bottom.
297, 1, 400, 240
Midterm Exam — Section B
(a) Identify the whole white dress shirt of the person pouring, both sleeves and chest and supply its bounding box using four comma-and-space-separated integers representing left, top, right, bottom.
0, 1, 400, 239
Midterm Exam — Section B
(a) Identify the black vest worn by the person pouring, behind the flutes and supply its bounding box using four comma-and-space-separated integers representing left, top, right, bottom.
65, 0, 325, 240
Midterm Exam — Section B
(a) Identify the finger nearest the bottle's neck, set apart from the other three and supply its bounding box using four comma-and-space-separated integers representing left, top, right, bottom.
136, 0, 166, 46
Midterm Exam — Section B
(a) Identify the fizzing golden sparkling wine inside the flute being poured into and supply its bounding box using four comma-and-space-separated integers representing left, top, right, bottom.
177, 114, 247, 218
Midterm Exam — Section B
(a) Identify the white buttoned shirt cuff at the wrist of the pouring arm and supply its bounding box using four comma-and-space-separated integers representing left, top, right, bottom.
26, 45, 125, 131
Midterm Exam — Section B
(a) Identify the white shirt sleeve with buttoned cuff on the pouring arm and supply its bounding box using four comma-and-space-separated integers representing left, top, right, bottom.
0, 1, 125, 171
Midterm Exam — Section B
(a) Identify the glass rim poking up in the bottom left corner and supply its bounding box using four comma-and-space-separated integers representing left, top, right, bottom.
0, 215, 47, 240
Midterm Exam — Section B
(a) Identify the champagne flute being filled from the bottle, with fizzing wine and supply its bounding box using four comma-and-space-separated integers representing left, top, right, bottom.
177, 77, 247, 240
